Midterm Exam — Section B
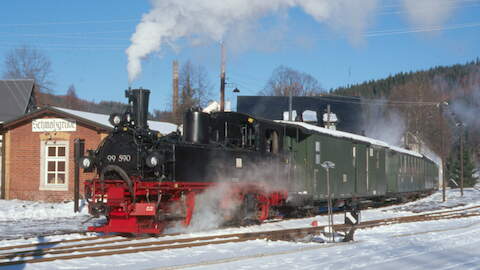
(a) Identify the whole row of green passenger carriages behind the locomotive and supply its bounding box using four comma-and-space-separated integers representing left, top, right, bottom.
284, 122, 438, 207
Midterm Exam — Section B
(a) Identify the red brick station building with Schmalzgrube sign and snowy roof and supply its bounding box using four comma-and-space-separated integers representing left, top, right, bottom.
0, 107, 176, 202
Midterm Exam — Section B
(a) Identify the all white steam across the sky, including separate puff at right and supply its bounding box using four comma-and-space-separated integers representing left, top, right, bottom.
126, 0, 458, 83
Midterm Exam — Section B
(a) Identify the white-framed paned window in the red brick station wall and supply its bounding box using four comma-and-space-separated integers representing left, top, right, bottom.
40, 141, 69, 190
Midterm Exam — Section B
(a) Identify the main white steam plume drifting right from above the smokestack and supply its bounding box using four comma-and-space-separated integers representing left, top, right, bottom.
126, 0, 378, 83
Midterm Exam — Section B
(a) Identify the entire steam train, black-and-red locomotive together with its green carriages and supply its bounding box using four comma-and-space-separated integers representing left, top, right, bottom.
80, 89, 438, 234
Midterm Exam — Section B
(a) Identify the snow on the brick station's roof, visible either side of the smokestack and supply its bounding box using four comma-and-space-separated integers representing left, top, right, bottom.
53, 107, 177, 134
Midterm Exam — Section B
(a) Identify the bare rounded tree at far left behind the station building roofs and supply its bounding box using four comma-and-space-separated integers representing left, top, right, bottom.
3, 46, 53, 93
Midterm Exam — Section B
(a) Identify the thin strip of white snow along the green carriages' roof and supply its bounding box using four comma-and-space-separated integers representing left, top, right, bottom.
275, 120, 423, 157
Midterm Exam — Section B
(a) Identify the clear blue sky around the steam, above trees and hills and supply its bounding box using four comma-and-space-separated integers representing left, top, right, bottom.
0, 0, 480, 110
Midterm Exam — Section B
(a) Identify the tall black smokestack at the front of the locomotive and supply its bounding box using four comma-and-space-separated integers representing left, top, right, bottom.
125, 89, 150, 129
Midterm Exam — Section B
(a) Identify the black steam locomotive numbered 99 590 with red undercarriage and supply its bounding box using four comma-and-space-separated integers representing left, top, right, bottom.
81, 89, 287, 233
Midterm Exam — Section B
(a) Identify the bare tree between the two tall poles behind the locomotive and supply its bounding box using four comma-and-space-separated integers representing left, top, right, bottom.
172, 61, 212, 122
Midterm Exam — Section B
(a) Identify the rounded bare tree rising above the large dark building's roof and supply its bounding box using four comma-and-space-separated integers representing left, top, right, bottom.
259, 66, 323, 96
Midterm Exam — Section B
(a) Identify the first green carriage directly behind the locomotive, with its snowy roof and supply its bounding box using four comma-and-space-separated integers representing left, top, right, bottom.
283, 122, 387, 206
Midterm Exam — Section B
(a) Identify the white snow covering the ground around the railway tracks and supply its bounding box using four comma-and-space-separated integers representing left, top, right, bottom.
0, 189, 480, 270
